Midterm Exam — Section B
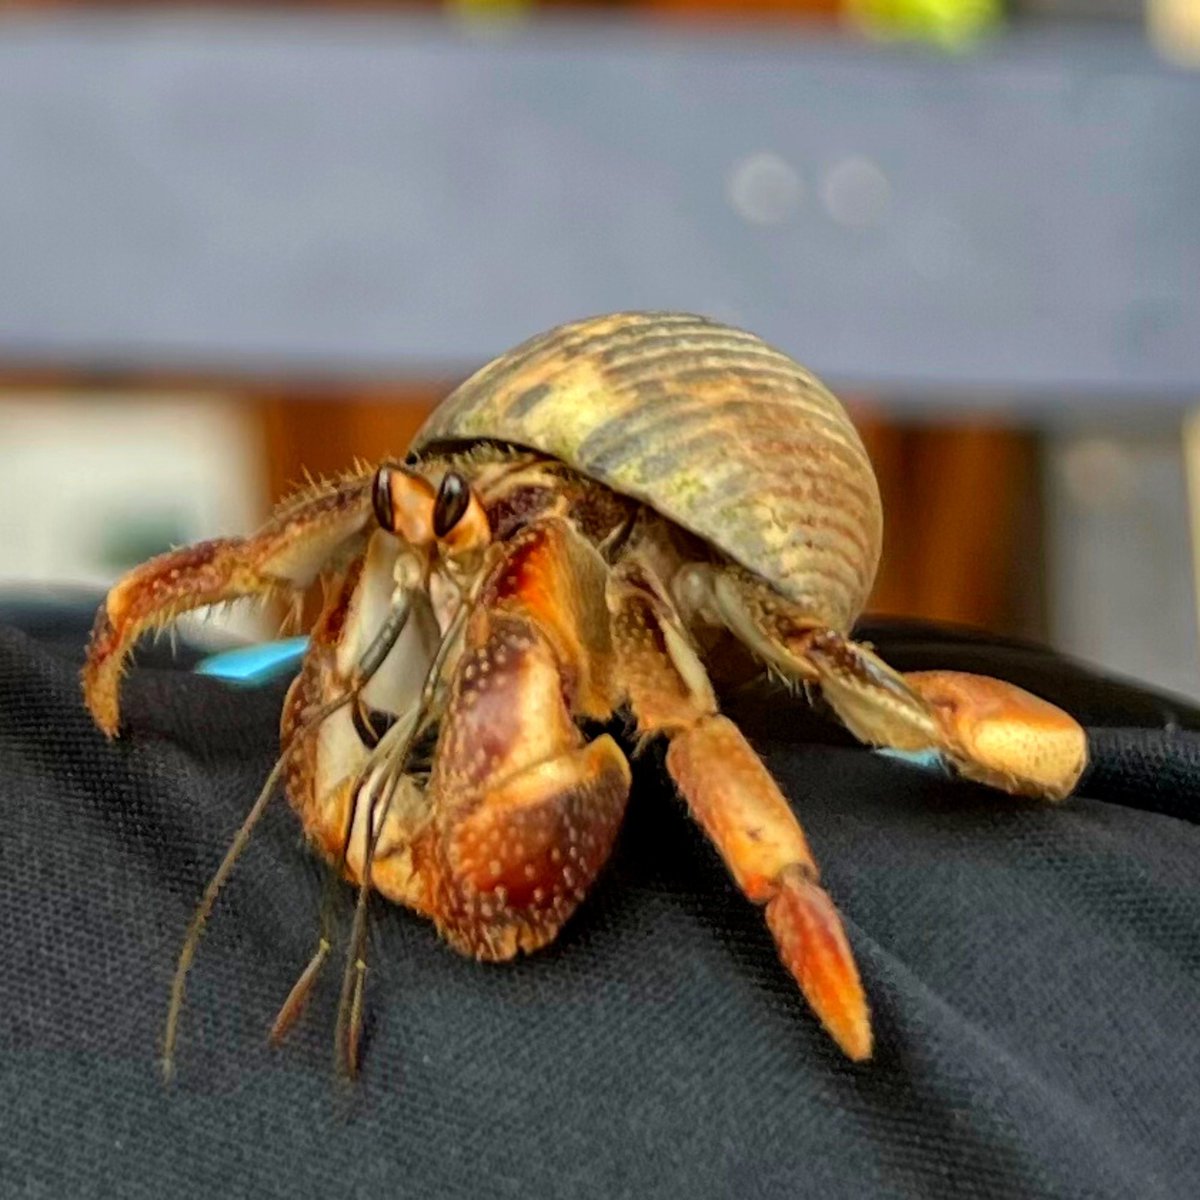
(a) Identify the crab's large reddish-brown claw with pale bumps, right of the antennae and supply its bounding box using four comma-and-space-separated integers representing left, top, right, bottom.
413, 518, 630, 960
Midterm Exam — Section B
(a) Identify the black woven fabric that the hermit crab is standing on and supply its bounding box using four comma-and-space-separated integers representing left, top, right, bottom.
0, 604, 1200, 1198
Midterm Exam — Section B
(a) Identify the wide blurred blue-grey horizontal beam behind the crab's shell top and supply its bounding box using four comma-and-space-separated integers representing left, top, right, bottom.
0, 13, 1200, 404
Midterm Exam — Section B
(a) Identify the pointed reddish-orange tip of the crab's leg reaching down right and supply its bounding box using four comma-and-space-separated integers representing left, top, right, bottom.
767, 869, 872, 1062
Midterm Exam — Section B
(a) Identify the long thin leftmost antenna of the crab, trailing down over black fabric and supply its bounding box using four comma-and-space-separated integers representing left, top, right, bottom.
162, 576, 422, 1080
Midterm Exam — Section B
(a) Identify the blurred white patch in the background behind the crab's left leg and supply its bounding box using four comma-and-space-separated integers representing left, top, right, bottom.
0, 394, 276, 641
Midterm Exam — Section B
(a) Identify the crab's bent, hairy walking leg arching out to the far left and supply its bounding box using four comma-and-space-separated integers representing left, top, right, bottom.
83, 474, 371, 737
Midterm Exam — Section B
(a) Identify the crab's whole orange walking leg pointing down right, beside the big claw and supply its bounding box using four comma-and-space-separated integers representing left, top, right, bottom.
608, 560, 871, 1060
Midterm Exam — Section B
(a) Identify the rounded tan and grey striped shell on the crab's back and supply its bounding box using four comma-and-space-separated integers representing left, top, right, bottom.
414, 312, 882, 630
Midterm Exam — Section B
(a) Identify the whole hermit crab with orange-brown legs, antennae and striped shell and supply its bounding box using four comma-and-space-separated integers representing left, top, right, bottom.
83, 313, 1086, 1070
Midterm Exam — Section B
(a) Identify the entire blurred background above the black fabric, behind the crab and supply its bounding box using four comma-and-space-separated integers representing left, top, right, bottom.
0, 0, 1200, 697
